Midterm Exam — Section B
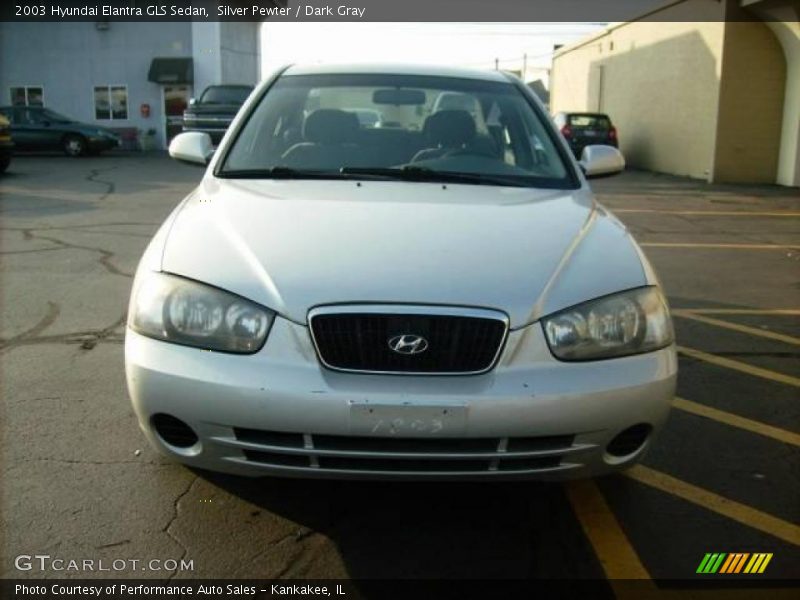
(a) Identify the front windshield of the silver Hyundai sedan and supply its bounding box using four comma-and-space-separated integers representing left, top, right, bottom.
217, 74, 574, 188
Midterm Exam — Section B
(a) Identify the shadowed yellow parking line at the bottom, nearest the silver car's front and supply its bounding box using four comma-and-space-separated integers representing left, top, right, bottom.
566, 479, 650, 583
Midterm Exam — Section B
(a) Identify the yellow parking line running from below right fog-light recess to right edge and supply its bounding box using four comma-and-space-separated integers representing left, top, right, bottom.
624, 465, 800, 546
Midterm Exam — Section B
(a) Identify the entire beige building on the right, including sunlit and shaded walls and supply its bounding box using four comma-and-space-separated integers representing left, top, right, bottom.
550, 0, 800, 185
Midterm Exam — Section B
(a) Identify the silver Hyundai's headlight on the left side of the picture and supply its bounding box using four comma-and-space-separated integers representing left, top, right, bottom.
128, 273, 275, 354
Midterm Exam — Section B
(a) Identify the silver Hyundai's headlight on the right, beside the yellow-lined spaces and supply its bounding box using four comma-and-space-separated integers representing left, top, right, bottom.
542, 287, 673, 360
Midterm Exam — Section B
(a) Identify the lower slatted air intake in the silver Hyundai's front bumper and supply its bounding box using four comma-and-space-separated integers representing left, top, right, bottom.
228, 427, 585, 475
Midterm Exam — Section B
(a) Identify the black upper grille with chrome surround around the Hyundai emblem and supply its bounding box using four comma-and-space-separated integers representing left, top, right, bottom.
309, 309, 507, 374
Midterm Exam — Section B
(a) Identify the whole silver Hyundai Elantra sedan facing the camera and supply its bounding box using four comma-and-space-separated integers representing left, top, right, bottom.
125, 66, 677, 479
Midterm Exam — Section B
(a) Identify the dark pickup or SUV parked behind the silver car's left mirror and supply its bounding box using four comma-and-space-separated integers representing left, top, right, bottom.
183, 85, 253, 144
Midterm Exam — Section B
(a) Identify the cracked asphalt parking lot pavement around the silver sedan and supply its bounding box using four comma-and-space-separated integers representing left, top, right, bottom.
0, 156, 800, 598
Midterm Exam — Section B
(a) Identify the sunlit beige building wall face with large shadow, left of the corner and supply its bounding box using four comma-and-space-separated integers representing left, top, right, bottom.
550, 2, 725, 178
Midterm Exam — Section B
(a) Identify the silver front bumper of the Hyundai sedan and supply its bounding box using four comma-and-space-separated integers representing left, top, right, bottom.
125, 318, 677, 479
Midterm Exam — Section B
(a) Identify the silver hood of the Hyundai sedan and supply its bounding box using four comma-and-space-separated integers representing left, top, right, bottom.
158, 176, 648, 327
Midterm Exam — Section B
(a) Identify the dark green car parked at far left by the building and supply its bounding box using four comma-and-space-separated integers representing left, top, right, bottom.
0, 106, 120, 156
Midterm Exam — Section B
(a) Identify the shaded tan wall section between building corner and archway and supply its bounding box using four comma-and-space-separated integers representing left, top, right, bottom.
712, 21, 786, 183
